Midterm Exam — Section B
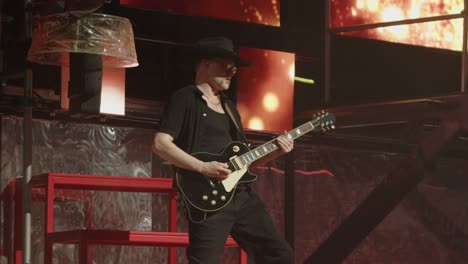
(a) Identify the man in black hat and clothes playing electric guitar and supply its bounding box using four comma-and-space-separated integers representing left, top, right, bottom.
153, 37, 294, 264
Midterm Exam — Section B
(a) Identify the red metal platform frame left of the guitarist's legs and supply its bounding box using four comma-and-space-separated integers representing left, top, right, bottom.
10, 173, 247, 264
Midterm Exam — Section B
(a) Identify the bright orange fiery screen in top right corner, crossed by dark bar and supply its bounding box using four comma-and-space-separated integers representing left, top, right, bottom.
331, 0, 464, 50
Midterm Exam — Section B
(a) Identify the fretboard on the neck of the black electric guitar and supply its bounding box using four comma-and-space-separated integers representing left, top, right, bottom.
239, 121, 315, 166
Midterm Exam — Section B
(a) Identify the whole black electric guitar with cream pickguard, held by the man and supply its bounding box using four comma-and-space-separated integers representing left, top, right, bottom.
175, 111, 335, 212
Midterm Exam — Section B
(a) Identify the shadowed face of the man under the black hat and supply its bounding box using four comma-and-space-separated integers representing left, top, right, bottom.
206, 58, 237, 91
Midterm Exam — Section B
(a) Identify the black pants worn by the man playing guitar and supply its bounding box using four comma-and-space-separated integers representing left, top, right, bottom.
187, 190, 294, 264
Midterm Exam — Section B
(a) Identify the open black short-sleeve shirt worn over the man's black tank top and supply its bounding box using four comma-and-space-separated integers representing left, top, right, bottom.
158, 85, 245, 153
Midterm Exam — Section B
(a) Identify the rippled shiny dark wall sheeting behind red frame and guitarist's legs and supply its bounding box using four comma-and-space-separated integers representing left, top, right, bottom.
1, 116, 468, 264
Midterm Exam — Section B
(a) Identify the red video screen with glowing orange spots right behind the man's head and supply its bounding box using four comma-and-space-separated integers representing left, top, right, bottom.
237, 47, 295, 133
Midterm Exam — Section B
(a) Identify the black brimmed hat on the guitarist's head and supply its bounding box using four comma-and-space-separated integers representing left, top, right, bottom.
197, 37, 251, 66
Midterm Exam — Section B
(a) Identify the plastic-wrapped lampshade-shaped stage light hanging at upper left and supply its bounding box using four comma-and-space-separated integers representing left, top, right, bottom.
28, 12, 138, 115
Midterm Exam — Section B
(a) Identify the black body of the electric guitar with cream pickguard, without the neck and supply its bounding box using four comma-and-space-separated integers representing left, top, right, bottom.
175, 141, 257, 212
